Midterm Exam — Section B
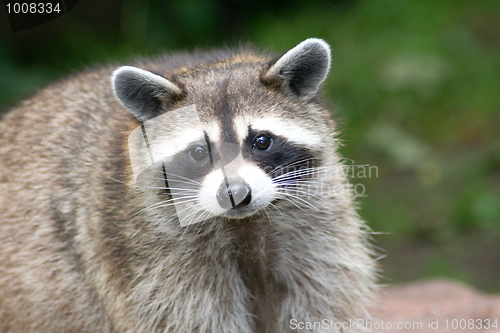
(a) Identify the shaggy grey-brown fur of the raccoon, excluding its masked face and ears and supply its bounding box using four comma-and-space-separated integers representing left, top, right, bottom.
0, 38, 376, 333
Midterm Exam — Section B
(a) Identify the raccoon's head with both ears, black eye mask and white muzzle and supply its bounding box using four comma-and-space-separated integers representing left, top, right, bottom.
112, 38, 332, 225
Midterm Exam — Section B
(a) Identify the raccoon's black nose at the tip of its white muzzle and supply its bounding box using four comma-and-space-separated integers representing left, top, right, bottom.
217, 179, 252, 209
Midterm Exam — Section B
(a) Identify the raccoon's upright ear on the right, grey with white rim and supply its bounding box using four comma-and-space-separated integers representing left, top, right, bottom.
262, 38, 331, 99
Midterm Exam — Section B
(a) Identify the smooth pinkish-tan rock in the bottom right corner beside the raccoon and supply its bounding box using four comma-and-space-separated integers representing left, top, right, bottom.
368, 280, 500, 333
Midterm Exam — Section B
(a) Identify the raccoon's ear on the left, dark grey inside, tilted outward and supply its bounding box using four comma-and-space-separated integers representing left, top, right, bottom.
111, 66, 182, 122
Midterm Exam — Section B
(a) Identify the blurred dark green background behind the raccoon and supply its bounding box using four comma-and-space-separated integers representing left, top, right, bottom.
0, 0, 500, 292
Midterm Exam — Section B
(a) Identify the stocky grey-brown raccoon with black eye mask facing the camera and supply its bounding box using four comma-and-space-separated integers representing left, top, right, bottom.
0, 38, 377, 333
